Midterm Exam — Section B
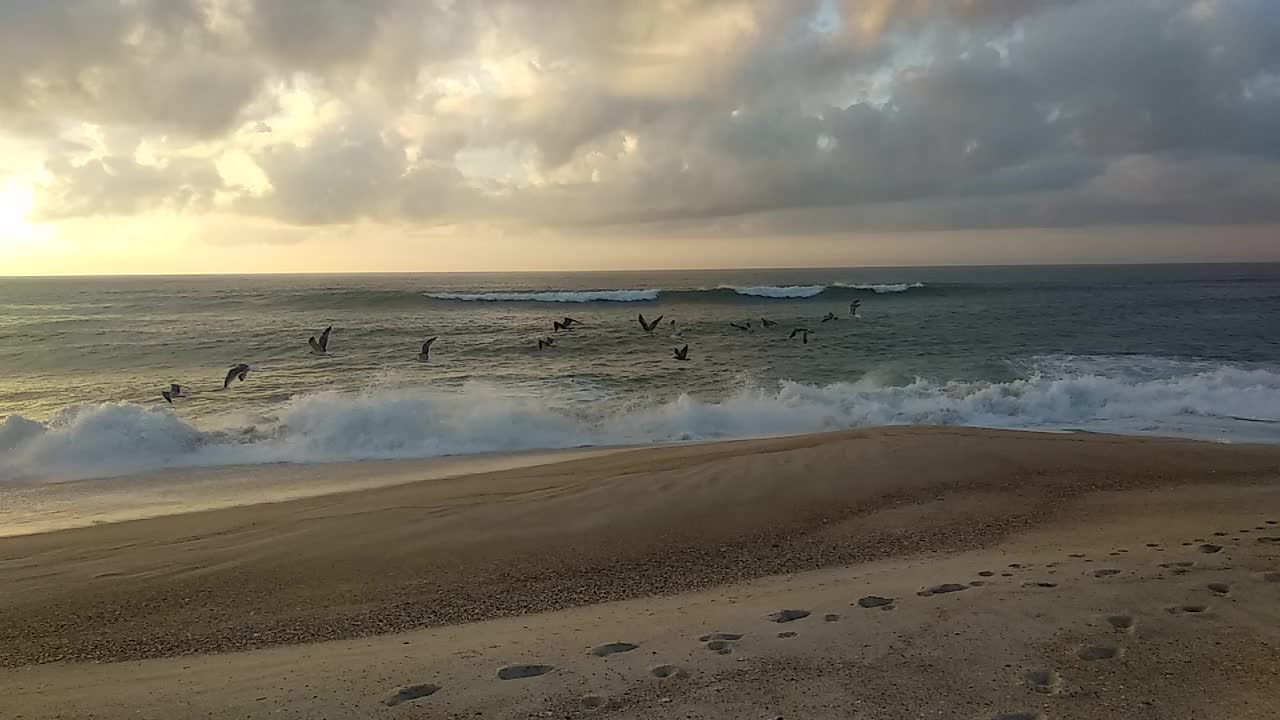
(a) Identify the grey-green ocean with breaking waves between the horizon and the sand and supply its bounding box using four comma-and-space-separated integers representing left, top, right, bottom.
0, 260, 1280, 483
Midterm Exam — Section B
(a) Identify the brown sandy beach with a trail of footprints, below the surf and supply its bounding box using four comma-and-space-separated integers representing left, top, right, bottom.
0, 428, 1280, 720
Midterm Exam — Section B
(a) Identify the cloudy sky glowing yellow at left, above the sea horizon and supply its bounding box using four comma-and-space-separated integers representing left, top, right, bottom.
0, 0, 1280, 275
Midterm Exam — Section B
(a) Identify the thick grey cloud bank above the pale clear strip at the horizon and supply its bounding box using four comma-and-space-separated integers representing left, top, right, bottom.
15, 0, 1280, 232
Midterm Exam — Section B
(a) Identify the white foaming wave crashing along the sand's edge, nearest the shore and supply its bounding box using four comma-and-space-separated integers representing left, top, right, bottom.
0, 356, 1280, 482
